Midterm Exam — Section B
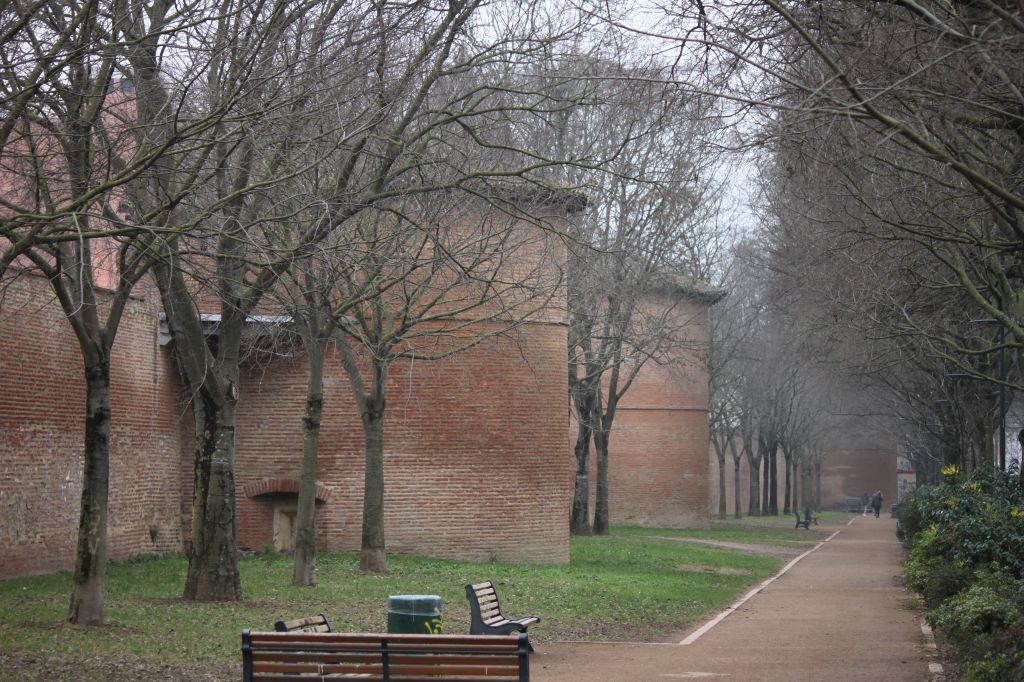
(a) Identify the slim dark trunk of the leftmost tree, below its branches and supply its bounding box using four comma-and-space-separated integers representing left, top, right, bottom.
68, 356, 111, 625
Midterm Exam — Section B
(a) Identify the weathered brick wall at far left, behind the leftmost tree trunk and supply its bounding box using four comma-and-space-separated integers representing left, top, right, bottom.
0, 273, 181, 578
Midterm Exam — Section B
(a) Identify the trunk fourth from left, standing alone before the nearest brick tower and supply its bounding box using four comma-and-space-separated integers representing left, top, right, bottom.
359, 393, 387, 573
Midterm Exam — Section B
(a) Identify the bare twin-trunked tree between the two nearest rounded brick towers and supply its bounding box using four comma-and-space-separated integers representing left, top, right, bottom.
561, 69, 719, 535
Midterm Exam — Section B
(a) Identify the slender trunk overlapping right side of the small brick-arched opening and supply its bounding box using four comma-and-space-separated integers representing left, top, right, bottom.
292, 337, 324, 587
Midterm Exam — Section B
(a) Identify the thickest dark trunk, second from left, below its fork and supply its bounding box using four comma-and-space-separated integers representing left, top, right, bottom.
184, 389, 242, 601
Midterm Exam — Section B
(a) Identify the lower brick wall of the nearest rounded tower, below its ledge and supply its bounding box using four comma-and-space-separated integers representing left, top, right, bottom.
237, 324, 572, 562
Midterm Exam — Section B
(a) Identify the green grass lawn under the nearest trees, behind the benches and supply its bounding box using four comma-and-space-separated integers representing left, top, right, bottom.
0, 531, 781, 680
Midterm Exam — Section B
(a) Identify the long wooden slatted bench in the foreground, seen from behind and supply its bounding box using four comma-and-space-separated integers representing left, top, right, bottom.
242, 630, 529, 682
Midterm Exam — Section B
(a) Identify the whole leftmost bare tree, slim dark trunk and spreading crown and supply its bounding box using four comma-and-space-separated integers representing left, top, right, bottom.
0, 2, 253, 624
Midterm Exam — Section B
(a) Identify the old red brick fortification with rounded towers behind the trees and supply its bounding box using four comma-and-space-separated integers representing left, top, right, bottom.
0, 222, 710, 578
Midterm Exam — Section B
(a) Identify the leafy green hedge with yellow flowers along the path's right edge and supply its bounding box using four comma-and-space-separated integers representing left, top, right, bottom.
899, 467, 1024, 682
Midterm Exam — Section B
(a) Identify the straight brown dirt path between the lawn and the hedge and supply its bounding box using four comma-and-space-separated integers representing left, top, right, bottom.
530, 517, 939, 682
